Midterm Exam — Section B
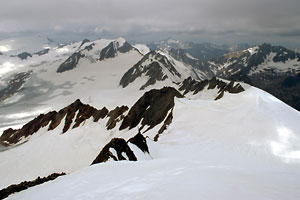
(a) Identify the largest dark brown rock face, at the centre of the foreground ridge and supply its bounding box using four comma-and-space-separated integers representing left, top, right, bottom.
120, 87, 183, 130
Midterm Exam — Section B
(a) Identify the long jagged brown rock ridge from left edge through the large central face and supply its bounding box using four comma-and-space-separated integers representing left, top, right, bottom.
0, 87, 183, 145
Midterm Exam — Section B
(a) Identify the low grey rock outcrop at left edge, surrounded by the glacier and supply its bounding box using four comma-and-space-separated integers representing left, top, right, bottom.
0, 71, 32, 102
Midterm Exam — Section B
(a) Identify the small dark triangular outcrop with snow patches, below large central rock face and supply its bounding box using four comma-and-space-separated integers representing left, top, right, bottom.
92, 138, 137, 165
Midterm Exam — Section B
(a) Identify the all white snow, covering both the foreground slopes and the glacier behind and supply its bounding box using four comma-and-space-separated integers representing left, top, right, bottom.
0, 36, 300, 200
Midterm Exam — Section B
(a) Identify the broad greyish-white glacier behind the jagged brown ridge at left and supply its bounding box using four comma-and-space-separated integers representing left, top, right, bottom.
0, 39, 142, 132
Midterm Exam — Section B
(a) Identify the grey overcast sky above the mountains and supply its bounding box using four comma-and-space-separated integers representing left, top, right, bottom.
0, 0, 300, 46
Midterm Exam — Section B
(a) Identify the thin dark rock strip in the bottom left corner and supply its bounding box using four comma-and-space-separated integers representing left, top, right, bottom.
0, 172, 66, 199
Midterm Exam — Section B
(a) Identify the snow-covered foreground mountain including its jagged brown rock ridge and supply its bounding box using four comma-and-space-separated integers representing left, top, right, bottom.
0, 79, 300, 199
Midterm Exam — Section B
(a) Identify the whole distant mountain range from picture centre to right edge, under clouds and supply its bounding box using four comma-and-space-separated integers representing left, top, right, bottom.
149, 41, 300, 110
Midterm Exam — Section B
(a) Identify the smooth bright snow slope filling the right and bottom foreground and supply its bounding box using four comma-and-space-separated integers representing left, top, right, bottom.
1, 85, 300, 200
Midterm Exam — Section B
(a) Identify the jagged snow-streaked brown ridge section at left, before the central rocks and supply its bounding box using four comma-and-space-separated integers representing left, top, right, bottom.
0, 99, 108, 145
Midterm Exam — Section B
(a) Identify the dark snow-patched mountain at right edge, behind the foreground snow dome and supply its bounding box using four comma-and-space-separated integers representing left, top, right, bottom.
209, 44, 300, 110
